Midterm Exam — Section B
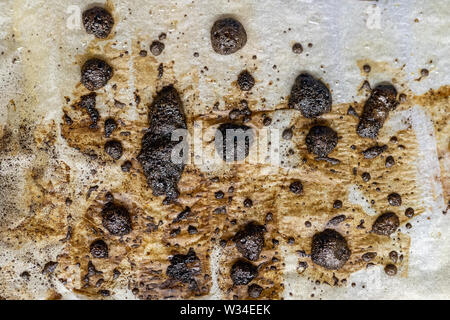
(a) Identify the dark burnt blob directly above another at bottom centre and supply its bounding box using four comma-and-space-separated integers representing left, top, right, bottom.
233, 222, 266, 261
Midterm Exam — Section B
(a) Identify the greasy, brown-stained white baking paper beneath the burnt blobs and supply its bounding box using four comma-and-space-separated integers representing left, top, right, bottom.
0, 0, 450, 299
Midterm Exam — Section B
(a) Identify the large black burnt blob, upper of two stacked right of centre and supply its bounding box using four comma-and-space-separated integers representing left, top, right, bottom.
288, 73, 331, 118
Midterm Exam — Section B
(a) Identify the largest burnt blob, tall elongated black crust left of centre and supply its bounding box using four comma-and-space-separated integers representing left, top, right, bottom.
138, 86, 187, 201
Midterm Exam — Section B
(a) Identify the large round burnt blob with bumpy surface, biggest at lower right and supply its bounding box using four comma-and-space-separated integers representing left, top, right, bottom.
311, 229, 351, 270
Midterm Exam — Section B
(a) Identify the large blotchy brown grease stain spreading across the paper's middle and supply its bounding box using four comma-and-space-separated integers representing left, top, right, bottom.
1, 26, 426, 299
